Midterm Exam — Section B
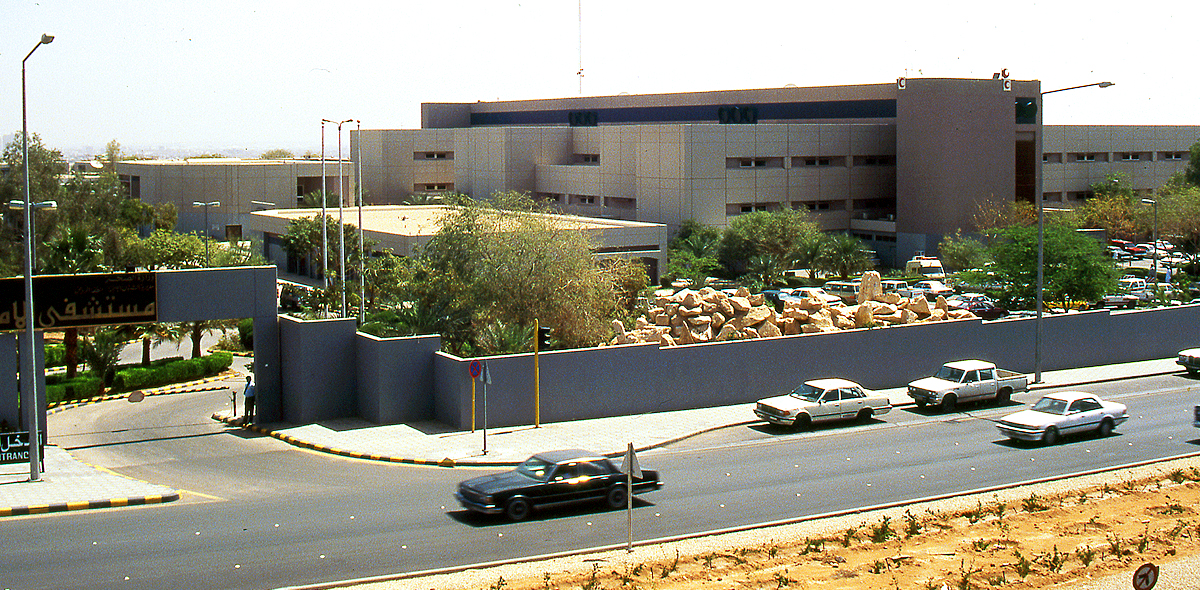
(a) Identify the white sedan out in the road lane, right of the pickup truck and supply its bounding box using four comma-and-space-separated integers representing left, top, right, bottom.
996, 391, 1129, 445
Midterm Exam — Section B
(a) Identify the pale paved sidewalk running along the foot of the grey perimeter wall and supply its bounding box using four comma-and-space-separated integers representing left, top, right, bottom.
212, 359, 1181, 466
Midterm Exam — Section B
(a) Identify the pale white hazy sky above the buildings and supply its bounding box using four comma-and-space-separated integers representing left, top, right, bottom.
0, 0, 1200, 158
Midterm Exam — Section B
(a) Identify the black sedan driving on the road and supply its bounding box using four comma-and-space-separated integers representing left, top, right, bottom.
455, 448, 662, 520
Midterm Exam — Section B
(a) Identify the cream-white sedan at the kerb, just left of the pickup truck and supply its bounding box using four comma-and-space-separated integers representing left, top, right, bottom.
754, 379, 892, 428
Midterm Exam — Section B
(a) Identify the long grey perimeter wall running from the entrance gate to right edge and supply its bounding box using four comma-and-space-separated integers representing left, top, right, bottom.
282, 306, 1200, 428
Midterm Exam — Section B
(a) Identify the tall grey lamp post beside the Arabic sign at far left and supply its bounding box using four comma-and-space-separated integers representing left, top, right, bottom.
20, 34, 54, 481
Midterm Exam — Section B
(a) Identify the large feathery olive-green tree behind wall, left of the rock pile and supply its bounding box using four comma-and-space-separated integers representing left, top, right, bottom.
413, 192, 640, 351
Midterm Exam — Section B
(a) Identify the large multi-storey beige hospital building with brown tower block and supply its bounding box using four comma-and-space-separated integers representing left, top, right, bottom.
350, 78, 1200, 264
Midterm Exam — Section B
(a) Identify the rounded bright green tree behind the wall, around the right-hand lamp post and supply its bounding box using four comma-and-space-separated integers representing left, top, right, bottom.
992, 223, 1120, 307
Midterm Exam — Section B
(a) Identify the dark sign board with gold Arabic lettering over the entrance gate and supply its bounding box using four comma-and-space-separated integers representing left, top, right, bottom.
0, 272, 158, 330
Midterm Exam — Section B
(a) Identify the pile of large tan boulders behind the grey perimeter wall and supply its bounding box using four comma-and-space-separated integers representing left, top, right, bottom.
610, 272, 976, 347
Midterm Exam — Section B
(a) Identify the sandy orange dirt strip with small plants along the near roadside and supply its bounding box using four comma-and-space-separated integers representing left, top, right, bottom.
365, 458, 1200, 590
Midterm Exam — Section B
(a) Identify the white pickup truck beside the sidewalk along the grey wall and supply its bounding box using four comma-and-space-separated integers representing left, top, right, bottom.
908, 361, 1030, 411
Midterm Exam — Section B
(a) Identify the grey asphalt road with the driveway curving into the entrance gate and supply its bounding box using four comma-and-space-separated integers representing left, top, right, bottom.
9, 375, 1200, 589
